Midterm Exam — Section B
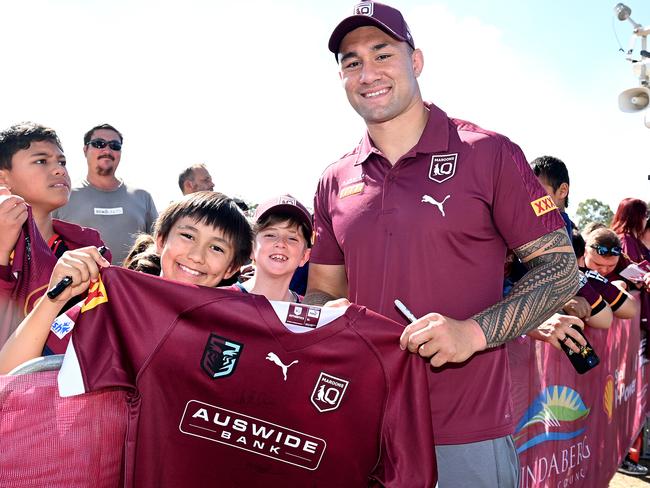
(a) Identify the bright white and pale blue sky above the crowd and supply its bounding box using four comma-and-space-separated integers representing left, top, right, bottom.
0, 0, 650, 217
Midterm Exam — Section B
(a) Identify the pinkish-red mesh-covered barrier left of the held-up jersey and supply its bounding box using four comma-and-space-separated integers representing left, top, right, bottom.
0, 364, 127, 488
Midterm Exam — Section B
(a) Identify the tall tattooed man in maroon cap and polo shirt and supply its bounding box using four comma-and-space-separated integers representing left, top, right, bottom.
305, 2, 579, 487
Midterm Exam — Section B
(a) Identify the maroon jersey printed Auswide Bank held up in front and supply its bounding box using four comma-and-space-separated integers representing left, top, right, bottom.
59, 268, 436, 488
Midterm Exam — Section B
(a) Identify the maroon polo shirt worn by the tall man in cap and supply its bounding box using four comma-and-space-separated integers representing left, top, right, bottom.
311, 101, 564, 444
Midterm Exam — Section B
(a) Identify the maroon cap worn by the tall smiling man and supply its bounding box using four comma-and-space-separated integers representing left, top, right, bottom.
328, 2, 415, 56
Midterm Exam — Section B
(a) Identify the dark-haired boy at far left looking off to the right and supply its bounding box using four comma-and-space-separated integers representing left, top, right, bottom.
0, 122, 110, 352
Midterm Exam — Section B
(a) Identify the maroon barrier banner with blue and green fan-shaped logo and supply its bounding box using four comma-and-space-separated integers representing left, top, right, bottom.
507, 308, 650, 488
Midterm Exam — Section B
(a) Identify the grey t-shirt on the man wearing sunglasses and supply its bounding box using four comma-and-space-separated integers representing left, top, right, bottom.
53, 180, 158, 265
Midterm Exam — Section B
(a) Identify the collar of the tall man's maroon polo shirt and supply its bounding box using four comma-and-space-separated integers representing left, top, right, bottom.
354, 102, 449, 166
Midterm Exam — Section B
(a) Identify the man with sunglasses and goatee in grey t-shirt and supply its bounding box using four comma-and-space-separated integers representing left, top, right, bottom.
56, 124, 158, 264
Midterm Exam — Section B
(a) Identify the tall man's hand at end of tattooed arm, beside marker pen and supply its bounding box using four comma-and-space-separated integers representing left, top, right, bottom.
400, 313, 487, 367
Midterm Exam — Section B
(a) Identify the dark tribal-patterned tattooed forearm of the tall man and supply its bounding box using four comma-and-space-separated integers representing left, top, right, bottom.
472, 229, 579, 347
